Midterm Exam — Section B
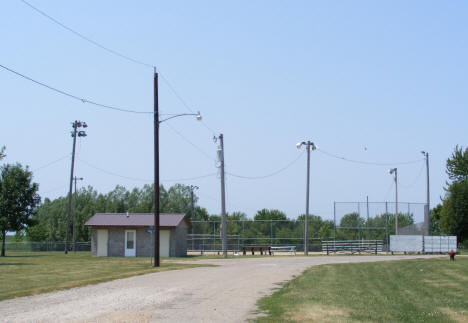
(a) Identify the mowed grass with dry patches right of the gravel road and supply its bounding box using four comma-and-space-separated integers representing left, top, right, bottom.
257, 256, 468, 322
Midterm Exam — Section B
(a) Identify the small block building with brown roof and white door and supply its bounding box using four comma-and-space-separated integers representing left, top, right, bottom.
85, 213, 191, 257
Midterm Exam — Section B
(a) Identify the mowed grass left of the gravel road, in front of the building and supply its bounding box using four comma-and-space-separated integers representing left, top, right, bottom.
0, 252, 207, 300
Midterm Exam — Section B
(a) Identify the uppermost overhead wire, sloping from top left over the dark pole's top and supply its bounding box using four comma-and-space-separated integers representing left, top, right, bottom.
20, 0, 216, 134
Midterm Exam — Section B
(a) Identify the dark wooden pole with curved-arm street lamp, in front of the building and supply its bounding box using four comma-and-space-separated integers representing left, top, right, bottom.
153, 68, 202, 267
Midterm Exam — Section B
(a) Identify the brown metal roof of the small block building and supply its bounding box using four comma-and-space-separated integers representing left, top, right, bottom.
85, 213, 190, 227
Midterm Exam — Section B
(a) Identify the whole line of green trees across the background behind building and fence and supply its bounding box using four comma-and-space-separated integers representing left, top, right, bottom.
0, 146, 468, 254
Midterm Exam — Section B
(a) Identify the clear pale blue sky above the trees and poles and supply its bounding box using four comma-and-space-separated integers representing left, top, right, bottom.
0, 0, 468, 223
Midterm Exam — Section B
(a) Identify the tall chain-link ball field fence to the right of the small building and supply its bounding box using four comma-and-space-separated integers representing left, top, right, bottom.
187, 202, 425, 253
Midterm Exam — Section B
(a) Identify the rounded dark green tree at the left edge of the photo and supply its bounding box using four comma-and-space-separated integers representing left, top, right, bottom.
0, 164, 41, 256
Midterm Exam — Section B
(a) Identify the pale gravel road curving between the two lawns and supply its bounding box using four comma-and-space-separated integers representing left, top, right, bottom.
0, 256, 440, 322
